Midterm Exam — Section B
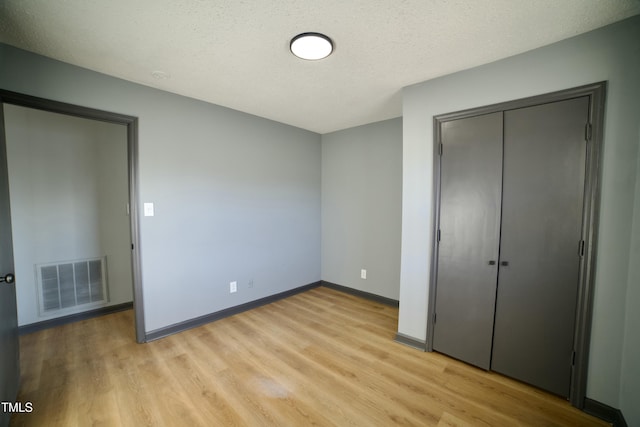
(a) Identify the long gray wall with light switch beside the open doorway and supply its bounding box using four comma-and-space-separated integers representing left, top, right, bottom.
0, 44, 321, 332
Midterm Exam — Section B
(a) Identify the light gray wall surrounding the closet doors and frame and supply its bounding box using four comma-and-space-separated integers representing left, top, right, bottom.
398, 16, 640, 425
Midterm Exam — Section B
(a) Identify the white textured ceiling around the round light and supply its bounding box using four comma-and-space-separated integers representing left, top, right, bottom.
0, 0, 640, 133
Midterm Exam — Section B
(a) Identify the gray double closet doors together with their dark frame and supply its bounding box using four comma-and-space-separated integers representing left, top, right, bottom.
428, 83, 605, 407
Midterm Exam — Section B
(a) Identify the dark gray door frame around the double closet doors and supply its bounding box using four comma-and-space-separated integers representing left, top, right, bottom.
426, 81, 607, 409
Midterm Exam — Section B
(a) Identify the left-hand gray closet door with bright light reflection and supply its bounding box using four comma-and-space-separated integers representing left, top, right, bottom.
433, 112, 502, 369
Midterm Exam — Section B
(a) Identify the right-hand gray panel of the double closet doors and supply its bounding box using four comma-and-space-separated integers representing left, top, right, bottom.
491, 97, 589, 396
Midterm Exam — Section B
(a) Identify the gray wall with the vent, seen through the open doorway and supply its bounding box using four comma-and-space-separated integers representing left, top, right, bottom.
4, 105, 133, 325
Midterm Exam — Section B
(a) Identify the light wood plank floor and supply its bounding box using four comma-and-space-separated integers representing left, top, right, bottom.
11, 288, 606, 427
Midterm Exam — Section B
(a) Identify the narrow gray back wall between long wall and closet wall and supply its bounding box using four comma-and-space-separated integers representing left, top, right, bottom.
322, 118, 402, 300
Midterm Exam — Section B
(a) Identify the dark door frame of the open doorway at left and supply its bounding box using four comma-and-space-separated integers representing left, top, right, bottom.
0, 89, 146, 343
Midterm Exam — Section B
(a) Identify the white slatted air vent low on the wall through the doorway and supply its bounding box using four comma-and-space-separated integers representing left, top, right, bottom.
36, 257, 108, 315
